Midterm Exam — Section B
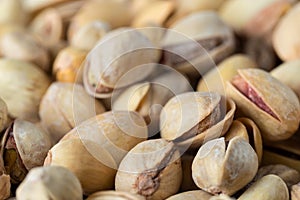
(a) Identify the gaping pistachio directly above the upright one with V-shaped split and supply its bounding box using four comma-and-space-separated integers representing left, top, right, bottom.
160, 92, 235, 148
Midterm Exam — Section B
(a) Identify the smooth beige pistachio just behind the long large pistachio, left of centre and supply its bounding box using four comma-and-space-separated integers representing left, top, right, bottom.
39, 82, 105, 144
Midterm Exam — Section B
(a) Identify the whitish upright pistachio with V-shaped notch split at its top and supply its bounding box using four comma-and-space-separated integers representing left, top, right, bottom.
192, 136, 258, 195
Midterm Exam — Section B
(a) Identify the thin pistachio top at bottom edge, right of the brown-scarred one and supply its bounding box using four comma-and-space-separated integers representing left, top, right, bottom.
166, 190, 212, 200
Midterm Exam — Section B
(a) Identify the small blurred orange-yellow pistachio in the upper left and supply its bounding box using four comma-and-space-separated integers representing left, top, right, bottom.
53, 46, 87, 83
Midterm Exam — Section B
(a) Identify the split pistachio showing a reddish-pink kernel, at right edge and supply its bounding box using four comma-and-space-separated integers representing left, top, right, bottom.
226, 69, 300, 141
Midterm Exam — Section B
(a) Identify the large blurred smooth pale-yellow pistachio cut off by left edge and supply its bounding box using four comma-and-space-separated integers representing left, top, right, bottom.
0, 59, 50, 121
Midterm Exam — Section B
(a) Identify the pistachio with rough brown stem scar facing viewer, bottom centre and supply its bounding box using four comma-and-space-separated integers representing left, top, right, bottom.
115, 139, 182, 199
